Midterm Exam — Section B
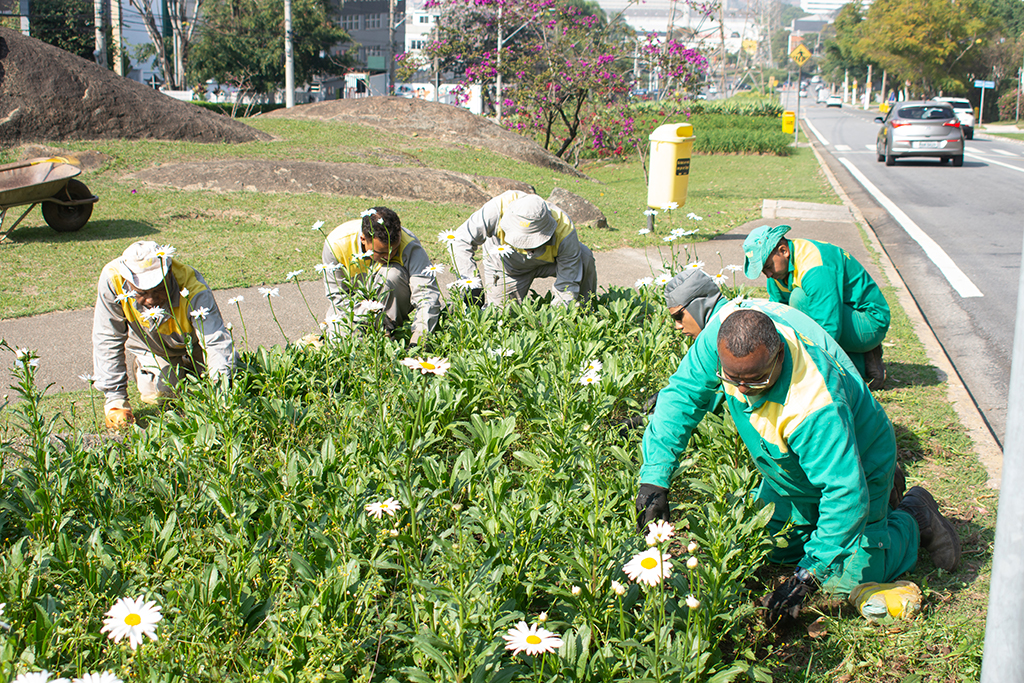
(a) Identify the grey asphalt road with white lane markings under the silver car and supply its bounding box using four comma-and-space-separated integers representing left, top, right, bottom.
788, 89, 1024, 445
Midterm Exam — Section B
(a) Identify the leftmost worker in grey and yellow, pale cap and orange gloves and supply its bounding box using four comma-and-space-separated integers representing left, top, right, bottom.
92, 242, 234, 429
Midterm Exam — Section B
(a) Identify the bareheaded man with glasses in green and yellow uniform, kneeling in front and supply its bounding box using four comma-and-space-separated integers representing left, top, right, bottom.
636, 301, 961, 621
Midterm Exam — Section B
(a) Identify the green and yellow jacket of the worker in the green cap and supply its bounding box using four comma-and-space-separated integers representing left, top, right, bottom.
768, 240, 890, 339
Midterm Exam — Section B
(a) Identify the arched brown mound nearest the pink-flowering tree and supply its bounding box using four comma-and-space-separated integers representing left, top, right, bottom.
263, 97, 587, 178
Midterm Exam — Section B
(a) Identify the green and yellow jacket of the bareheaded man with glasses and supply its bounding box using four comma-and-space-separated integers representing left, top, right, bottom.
640, 300, 896, 582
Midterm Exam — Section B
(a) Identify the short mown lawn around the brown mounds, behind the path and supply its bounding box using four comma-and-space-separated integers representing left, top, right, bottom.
0, 119, 837, 318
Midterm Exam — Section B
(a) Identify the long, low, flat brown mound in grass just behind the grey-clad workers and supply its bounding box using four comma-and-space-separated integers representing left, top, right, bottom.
126, 160, 534, 206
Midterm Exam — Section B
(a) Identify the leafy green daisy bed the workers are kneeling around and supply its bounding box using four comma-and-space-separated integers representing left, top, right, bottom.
0, 289, 771, 682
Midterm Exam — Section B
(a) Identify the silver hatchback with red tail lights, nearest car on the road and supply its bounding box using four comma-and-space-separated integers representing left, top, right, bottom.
874, 100, 964, 166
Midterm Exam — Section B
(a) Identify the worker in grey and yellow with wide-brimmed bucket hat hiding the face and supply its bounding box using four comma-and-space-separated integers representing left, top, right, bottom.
452, 189, 597, 304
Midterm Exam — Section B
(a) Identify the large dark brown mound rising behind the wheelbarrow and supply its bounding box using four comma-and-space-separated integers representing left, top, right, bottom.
0, 28, 271, 145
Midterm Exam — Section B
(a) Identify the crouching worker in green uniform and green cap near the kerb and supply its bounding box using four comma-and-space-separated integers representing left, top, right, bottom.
743, 225, 890, 390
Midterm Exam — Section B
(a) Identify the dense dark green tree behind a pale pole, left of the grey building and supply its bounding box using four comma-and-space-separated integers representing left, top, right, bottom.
189, 0, 351, 92
